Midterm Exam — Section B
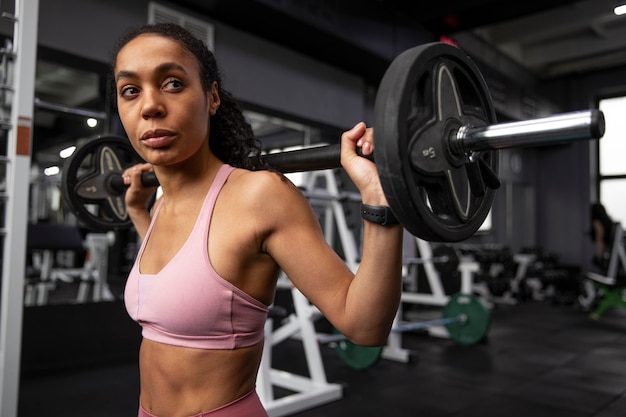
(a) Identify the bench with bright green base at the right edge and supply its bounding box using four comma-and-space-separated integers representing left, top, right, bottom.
579, 223, 626, 320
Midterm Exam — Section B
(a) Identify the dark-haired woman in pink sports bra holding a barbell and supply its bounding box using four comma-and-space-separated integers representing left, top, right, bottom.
114, 24, 403, 417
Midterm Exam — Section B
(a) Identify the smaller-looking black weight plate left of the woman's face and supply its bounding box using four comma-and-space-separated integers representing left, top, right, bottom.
61, 136, 141, 231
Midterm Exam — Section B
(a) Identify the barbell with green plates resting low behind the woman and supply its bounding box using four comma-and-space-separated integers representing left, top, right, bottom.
318, 293, 491, 370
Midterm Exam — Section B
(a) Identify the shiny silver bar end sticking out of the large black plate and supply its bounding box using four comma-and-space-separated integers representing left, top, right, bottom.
450, 109, 605, 155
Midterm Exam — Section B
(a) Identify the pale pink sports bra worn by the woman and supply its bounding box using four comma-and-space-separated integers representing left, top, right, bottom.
124, 164, 268, 349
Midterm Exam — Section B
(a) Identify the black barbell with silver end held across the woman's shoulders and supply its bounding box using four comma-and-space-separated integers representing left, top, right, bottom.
62, 42, 605, 242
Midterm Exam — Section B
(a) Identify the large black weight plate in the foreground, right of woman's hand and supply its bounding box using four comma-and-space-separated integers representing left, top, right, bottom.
374, 43, 498, 242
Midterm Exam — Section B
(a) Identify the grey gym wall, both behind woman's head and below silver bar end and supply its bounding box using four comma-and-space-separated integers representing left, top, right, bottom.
0, 0, 623, 266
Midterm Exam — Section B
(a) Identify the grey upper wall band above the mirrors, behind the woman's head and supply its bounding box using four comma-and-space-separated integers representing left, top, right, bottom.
38, 0, 365, 128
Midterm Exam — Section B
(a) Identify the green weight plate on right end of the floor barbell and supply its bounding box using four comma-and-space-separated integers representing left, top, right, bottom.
443, 294, 491, 345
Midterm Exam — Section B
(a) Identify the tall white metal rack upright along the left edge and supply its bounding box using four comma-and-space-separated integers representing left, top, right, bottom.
0, 0, 39, 417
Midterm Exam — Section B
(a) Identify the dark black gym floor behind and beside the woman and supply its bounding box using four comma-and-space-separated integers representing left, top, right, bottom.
19, 294, 626, 417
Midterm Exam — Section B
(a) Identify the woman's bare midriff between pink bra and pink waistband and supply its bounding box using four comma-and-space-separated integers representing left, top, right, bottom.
139, 339, 263, 417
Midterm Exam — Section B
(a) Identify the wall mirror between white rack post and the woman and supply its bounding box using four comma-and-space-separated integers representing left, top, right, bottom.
24, 48, 115, 306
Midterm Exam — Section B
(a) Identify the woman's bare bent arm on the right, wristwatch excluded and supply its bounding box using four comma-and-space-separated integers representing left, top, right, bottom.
270, 123, 403, 345
